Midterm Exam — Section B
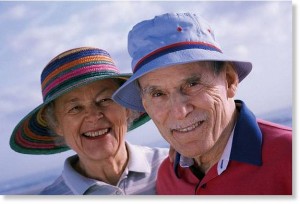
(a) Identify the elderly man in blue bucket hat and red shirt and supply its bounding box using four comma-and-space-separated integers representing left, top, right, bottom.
113, 13, 292, 195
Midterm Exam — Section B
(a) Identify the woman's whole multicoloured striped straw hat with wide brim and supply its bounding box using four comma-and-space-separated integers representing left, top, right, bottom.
10, 47, 150, 154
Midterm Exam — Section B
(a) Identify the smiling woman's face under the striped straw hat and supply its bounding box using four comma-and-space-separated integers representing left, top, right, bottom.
55, 79, 128, 160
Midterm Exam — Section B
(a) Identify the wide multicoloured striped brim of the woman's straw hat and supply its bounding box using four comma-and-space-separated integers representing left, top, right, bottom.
9, 74, 150, 155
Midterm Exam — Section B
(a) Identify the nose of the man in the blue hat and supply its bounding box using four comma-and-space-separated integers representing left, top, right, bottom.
170, 93, 193, 120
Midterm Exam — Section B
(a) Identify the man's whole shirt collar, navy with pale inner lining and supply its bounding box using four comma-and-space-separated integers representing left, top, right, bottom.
174, 100, 262, 176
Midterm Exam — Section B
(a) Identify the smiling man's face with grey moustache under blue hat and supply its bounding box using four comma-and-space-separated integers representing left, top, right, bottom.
139, 62, 237, 157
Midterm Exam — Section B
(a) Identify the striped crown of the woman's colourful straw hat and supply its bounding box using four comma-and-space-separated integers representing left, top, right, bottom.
41, 48, 119, 101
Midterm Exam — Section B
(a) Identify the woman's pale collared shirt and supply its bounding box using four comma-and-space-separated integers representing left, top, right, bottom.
40, 143, 169, 195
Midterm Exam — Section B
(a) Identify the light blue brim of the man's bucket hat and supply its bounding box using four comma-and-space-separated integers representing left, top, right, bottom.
113, 49, 252, 112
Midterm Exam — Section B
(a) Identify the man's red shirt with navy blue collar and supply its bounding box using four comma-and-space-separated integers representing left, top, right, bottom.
156, 101, 292, 195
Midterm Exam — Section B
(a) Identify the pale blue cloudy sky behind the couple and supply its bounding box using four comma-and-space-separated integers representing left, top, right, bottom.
0, 1, 294, 198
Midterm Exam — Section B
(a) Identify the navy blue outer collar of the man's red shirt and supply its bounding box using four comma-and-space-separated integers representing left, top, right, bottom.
174, 100, 262, 177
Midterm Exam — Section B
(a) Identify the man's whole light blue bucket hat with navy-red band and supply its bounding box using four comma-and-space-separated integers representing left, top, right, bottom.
113, 13, 252, 111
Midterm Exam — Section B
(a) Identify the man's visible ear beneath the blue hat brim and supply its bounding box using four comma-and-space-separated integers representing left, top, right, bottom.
225, 62, 239, 98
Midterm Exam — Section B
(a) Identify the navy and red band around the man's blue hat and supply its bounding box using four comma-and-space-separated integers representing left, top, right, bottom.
133, 42, 222, 73
